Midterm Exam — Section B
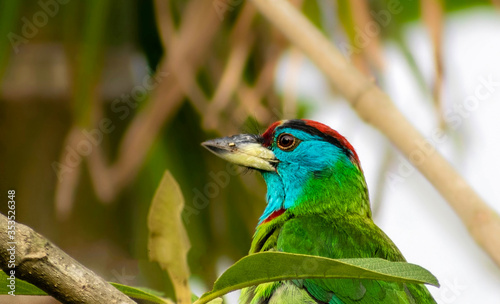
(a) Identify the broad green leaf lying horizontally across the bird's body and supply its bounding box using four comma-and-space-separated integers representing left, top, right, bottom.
194, 252, 439, 304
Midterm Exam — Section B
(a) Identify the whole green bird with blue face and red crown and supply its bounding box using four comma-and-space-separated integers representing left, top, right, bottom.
203, 119, 436, 304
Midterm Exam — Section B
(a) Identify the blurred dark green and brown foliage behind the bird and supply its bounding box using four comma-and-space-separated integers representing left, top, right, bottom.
0, 0, 498, 302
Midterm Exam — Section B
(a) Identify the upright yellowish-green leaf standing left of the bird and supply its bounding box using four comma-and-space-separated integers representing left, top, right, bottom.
148, 171, 191, 303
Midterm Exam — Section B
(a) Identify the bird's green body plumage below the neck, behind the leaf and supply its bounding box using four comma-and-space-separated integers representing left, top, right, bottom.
240, 211, 436, 304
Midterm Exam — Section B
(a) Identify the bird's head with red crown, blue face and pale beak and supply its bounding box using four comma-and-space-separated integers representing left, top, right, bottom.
203, 119, 371, 223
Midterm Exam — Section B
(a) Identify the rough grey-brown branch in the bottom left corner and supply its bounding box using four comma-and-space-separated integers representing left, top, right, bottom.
0, 214, 135, 304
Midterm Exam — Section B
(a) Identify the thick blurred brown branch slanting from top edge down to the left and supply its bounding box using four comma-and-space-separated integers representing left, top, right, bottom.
83, 0, 220, 200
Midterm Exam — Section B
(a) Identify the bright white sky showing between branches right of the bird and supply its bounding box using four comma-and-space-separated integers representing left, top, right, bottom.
277, 10, 500, 304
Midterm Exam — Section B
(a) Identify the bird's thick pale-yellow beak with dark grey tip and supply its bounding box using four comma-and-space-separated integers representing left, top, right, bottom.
202, 134, 278, 171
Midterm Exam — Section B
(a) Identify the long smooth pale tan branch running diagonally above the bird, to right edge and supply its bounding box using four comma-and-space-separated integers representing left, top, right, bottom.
252, 0, 500, 266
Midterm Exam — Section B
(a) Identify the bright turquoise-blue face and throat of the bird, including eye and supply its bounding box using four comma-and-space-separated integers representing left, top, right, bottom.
260, 127, 354, 222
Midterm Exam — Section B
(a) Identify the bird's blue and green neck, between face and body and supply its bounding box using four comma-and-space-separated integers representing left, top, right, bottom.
259, 162, 371, 225
